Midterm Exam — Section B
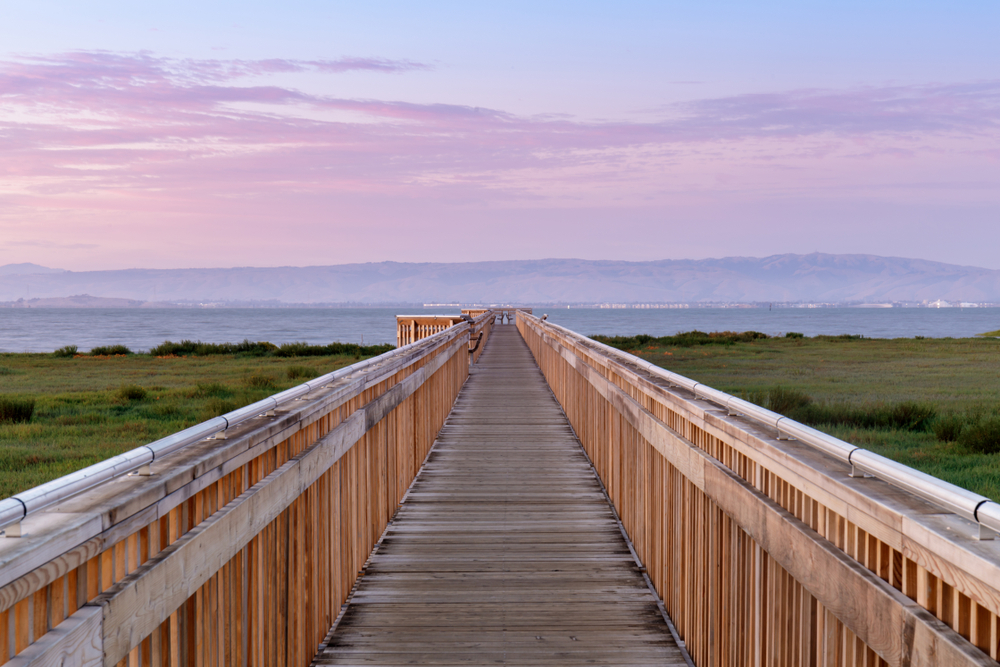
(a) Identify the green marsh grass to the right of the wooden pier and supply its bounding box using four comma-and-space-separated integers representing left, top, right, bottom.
596, 334, 1000, 501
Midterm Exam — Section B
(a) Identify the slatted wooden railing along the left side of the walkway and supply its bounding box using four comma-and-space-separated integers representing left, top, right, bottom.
0, 323, 470, 667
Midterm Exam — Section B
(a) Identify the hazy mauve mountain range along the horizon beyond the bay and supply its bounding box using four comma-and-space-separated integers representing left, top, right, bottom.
0, 253, 1000, 305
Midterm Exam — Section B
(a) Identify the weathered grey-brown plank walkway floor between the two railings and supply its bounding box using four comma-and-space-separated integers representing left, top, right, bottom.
314, 325, 686, 665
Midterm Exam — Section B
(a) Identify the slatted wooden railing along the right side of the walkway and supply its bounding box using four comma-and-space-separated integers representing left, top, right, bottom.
517, 313, 1000, 667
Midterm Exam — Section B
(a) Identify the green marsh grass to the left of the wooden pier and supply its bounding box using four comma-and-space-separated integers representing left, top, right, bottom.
0, 354, 372, 498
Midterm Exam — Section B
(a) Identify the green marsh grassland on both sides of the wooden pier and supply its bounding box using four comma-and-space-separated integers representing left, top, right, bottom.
0, 332, 1000, 500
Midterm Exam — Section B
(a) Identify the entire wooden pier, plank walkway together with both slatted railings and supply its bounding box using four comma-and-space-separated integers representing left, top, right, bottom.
0, 309, 1000, 667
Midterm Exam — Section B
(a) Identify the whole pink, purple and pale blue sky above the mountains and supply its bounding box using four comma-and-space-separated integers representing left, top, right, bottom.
0, 0, 1000, 270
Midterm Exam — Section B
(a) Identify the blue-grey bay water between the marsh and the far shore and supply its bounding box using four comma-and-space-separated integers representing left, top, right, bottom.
0, 307, 1000, 352
